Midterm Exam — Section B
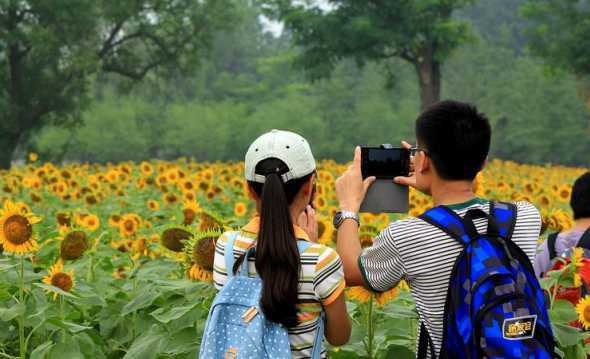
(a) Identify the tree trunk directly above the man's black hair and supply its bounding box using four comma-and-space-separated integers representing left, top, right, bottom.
414, 48, 440, 111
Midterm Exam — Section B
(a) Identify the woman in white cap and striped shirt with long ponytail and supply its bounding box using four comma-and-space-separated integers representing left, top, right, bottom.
213, 130, 351, 358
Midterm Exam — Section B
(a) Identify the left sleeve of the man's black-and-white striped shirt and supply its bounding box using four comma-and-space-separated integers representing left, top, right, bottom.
359, 221, 406, 292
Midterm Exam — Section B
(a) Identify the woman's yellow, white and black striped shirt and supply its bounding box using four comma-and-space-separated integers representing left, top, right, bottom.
213, 217, 345, 358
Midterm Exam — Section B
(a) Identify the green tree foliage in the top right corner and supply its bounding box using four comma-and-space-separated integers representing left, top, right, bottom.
522, 0, 590, 122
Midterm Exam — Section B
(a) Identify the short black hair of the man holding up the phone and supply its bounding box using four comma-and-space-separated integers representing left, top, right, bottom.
416, 100, 492, 181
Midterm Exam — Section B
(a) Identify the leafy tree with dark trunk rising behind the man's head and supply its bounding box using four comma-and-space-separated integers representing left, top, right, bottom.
266, 0, 472, 109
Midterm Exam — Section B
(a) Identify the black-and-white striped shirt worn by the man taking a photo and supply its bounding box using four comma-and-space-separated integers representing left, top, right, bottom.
359, 198, 541, 356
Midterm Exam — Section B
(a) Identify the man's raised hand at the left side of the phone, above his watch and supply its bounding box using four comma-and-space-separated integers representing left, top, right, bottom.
336, 146, 375, 213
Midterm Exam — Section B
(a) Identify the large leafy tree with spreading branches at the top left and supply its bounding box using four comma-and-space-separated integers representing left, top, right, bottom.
0, 0, 233, 168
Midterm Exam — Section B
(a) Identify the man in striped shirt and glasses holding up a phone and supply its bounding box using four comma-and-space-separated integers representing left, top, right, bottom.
336, 101, 541, 356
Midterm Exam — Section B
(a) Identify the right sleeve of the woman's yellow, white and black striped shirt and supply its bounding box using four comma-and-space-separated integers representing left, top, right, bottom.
313, 246, 346, 305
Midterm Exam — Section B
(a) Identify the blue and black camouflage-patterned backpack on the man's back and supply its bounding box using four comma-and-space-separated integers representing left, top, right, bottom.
418, 202, 555, 359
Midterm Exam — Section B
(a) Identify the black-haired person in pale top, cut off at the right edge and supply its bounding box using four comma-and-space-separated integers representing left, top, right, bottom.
534, 172, 590, 277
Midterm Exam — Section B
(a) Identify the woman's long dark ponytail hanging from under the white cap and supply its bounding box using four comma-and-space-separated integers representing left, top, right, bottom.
233, 158, 312, 328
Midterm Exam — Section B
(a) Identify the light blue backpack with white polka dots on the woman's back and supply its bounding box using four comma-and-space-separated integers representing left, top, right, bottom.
199, 232, 324, 359
